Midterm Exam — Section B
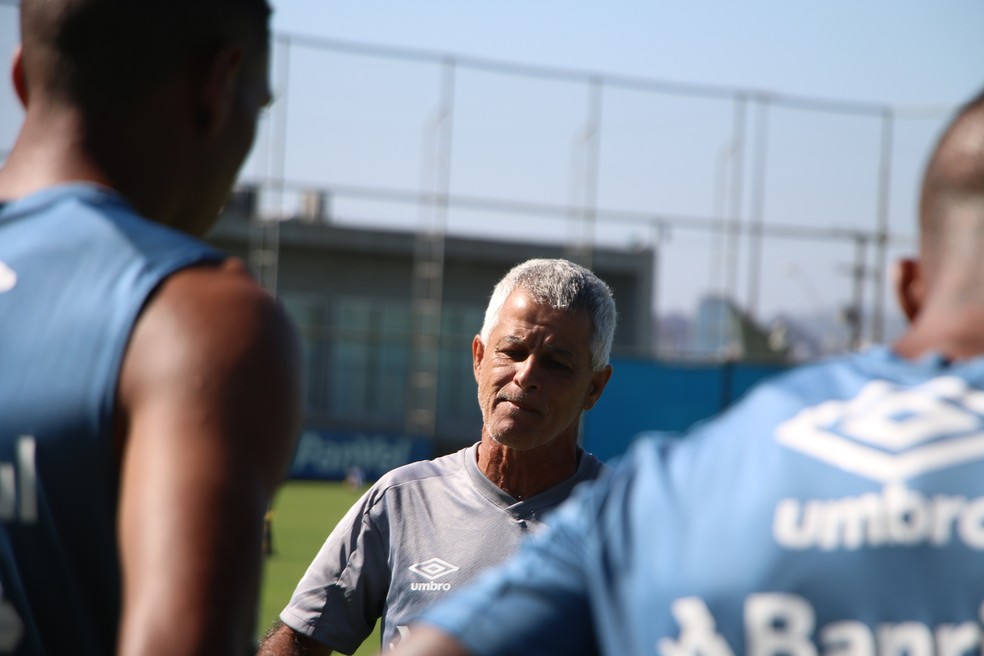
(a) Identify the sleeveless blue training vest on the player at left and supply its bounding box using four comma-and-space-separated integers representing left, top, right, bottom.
0, 184, 222, 655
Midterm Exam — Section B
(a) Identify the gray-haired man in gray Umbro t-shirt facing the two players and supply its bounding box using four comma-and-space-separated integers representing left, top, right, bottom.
260, 260, 616, 656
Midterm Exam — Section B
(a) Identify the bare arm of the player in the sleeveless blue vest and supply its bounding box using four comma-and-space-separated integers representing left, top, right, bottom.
117, 261, 301, 656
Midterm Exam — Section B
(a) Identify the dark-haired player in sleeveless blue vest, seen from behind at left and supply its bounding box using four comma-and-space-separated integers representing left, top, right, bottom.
0, 0, 300, 655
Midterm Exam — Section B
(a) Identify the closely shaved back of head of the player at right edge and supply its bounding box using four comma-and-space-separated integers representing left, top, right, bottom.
919, 88, 984, 284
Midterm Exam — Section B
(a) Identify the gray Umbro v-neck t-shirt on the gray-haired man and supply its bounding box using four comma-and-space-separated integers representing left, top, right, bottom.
280, 444, 606, 654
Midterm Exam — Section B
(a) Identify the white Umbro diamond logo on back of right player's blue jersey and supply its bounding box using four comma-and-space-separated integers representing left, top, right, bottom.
776, 376, 984, 483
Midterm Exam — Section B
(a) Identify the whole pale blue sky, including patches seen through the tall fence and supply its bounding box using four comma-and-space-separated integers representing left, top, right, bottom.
0, 0, 984, 336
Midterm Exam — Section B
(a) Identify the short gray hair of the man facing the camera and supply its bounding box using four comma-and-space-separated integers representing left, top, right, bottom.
480, 259, 617, 371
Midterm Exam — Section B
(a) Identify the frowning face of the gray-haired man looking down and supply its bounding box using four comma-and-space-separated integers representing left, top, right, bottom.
472, 290, 611, 450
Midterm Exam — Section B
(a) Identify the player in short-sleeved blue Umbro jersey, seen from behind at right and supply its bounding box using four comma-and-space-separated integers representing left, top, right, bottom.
390, 88, 984, 656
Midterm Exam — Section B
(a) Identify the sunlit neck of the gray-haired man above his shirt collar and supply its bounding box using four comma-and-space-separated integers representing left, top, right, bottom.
478, 431, 578, 501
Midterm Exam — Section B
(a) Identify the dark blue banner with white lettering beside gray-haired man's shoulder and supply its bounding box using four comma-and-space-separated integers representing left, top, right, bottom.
290, 430, 434, 481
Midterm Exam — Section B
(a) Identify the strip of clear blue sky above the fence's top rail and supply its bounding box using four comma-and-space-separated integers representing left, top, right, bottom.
274, 0, 984, 104
